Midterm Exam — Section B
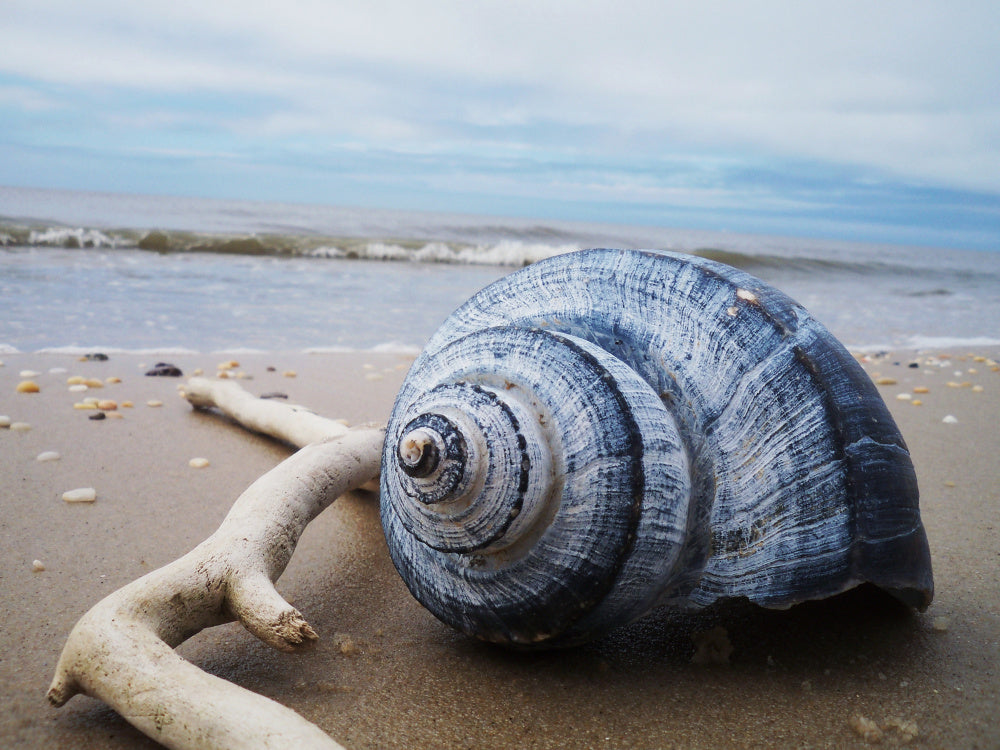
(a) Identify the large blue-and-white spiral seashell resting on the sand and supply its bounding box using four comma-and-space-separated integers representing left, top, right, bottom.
381, 250, 933, 647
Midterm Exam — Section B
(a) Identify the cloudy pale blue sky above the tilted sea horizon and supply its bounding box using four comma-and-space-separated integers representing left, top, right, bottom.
0, 0, 1000, 250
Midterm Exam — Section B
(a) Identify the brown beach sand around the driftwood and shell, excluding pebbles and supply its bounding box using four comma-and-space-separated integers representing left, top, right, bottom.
0, 350, 1000, 748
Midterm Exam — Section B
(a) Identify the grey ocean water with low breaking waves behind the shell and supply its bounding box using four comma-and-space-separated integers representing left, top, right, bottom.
0, 187, 1000, 353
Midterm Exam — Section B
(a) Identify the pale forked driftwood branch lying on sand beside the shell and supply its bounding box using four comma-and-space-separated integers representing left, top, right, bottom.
48, 378, 384, 750
